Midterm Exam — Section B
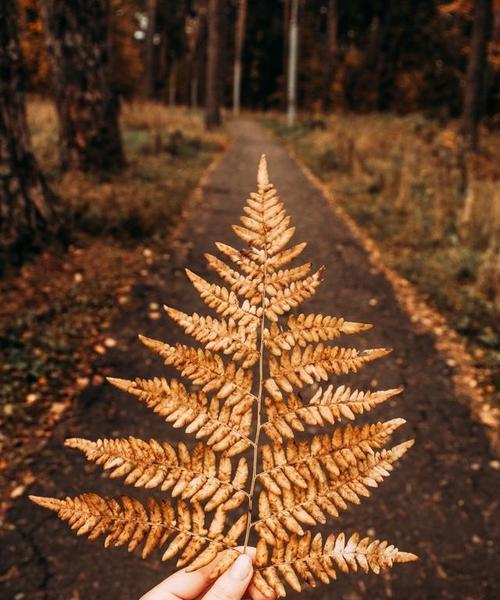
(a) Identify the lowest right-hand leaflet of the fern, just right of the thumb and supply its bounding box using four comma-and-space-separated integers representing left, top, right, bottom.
254, 532, 417, 597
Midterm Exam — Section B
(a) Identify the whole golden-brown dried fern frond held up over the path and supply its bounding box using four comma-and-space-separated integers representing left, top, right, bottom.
32, 156, 416, 596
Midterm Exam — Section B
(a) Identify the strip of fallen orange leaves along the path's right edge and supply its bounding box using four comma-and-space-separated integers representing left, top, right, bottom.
284, 144, 500, 456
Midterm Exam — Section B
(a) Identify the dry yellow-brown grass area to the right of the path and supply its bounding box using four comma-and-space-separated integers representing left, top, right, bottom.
265, 115, 500, 424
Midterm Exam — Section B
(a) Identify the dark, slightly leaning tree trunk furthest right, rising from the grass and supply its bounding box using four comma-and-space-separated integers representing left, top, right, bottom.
462, 0, 493, 150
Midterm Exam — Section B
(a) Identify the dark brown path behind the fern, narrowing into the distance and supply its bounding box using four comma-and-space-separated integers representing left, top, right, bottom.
0, 122, 500, 600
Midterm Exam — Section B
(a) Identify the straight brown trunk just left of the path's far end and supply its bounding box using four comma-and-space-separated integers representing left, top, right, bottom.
205, 0, 224, 129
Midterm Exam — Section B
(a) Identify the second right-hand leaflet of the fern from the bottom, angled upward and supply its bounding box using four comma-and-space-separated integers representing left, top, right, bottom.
255, 440, 413, 545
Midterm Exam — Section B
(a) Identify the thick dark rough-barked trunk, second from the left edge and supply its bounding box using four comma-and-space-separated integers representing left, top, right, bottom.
41, 0, 125, 171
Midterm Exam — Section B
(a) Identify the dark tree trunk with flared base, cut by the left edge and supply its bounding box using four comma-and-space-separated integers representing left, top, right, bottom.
0, 0, 56, 264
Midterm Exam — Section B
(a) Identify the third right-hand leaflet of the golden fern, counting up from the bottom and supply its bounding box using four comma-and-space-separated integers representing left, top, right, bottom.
257, 419, 405, 495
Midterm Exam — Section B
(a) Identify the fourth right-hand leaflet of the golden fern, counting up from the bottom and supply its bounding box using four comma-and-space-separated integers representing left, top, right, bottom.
262, 385, 402, 443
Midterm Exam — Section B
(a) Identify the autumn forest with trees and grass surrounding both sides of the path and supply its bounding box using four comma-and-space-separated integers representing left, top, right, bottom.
0, 0, 500, 564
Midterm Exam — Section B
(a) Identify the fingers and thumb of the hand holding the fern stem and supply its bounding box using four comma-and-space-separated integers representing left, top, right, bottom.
140, 548, 274, 600
